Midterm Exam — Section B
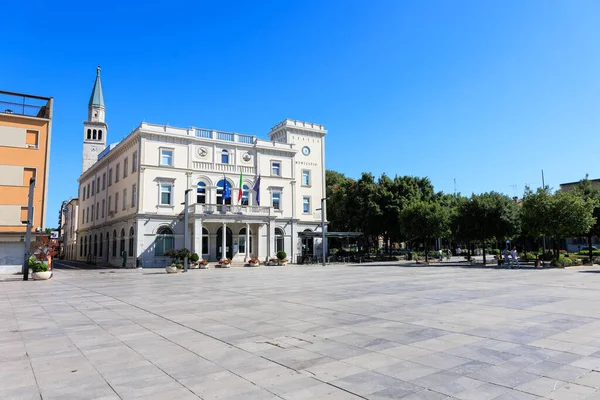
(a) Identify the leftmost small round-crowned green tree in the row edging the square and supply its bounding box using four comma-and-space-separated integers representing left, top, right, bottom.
400, 200, 450, 261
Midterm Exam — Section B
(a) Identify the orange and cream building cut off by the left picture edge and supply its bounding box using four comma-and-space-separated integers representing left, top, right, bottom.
0, 91, 53, 273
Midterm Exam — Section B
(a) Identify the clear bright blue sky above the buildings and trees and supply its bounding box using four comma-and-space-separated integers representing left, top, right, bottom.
0, 0, 600, 226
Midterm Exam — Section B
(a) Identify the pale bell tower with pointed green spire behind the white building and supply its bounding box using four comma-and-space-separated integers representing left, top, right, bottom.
81, 66, 108, 173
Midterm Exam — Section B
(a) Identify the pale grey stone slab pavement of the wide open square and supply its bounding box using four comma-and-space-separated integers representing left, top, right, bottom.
0, 264, 600, 400
